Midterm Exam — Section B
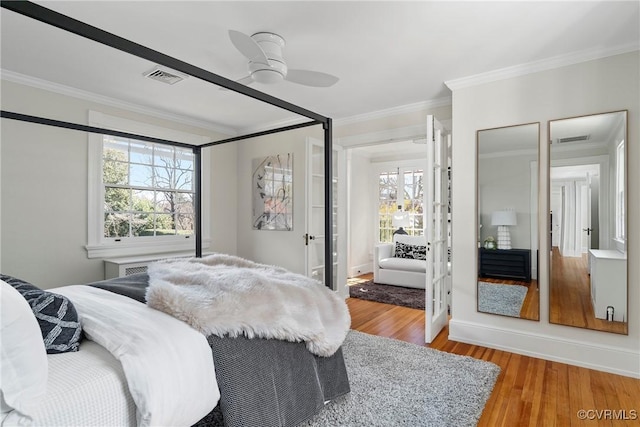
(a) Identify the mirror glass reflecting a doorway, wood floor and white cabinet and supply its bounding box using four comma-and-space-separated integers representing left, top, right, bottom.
549, 111, 628, 334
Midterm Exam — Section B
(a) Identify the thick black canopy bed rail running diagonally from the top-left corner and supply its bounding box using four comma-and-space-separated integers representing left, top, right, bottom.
1, 0, 327, 123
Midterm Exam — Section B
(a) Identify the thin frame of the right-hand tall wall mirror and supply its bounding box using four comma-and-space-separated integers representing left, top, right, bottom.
542, 110, 629, 335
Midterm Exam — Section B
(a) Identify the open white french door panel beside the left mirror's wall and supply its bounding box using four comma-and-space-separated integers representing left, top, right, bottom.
424, 115, 449, 343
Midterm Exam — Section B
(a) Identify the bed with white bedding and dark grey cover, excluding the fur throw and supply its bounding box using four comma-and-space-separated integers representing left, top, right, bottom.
1, 256, 350, 427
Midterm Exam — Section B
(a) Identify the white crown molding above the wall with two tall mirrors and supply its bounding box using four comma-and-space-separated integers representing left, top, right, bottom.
444, 42, 640, 90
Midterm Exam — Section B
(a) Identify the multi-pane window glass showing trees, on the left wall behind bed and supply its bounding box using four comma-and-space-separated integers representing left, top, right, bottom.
102, 135, 194, 240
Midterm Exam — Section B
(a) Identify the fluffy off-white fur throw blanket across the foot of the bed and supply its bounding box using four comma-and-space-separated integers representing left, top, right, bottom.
146, 254, 351, 356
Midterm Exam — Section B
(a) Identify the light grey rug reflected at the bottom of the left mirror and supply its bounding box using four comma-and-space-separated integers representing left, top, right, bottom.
478, 282, 527, 317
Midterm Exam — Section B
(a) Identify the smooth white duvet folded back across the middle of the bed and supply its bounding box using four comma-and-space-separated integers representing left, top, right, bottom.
26, 285, 220, 426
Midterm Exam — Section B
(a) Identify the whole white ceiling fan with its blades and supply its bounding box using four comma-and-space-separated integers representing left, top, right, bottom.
229, 30, 339, 87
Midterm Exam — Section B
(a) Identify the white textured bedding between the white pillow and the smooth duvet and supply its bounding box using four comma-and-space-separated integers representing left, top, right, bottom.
2, 340, 136, 427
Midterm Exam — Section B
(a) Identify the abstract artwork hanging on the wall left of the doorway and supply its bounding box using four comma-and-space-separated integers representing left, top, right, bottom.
251, 153, 293, 231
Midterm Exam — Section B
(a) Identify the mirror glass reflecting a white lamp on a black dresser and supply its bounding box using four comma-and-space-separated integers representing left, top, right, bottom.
477, 123, 540, 320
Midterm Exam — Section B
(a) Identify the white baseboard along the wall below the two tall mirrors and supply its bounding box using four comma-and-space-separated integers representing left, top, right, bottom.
449, 319, 640, 378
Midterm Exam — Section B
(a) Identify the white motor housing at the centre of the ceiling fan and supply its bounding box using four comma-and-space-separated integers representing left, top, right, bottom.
249, 32, 287, 84
